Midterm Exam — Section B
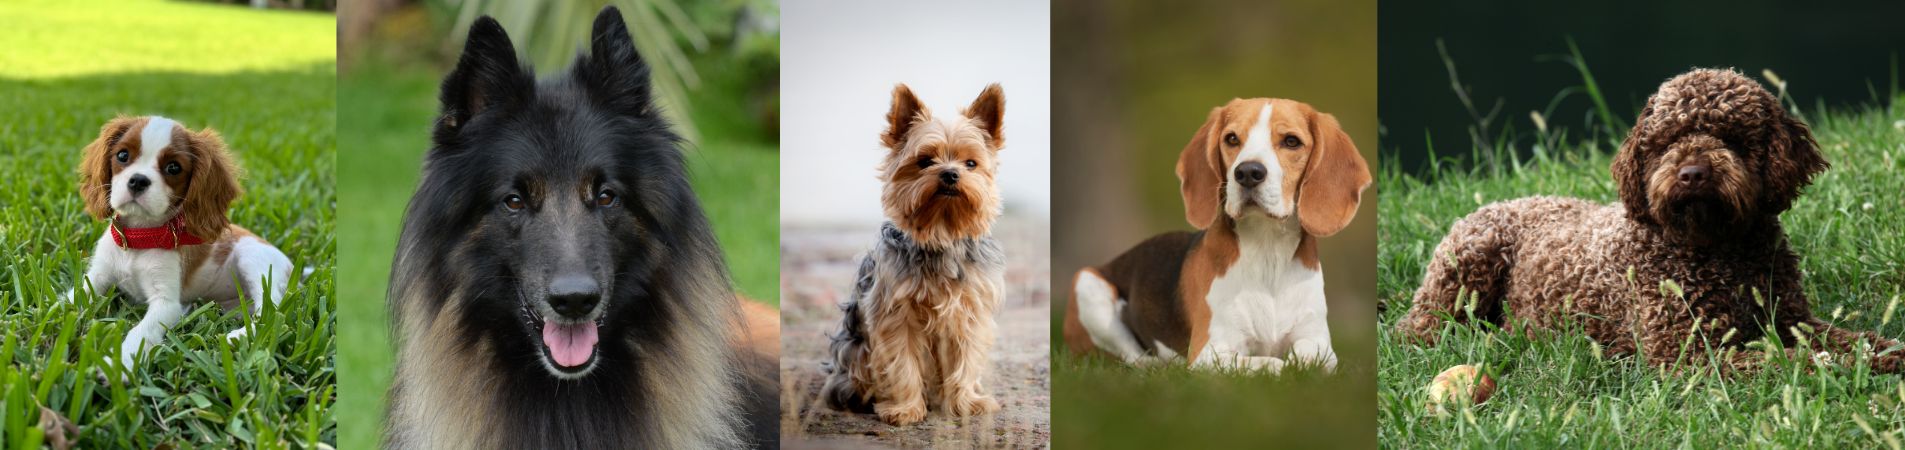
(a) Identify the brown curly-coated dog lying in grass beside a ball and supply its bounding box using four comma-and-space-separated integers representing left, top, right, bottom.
1396, 69, 1901, 372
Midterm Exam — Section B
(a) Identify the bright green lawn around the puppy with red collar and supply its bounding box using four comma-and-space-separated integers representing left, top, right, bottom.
0, 2, 337, 448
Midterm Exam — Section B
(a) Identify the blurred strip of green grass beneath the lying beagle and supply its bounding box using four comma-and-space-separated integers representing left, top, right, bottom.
1052, 350, 1375, 448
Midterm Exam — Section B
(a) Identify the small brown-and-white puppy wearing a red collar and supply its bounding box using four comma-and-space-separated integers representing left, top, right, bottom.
67, 116, 291, 368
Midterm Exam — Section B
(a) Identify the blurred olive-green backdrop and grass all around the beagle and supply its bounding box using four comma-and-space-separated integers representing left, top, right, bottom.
1052, 0, 1377, 448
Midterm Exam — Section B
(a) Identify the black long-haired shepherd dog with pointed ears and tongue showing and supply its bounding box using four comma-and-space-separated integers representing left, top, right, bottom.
385, 8, 779, 448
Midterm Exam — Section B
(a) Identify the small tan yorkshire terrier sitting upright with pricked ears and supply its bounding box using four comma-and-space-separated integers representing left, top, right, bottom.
825, 84, 1006, 425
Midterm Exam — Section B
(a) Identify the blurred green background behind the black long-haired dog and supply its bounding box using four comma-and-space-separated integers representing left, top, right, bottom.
337, 0, 779, 448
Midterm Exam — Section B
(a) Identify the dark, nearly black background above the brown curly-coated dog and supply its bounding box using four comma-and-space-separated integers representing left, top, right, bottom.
1377, 0, 1905, 174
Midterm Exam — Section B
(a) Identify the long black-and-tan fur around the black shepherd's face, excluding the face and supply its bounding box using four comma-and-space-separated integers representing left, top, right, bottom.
385, 8, 777, 448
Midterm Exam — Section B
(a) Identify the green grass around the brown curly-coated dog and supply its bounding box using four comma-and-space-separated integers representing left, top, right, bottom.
1377, 102, 1905, 448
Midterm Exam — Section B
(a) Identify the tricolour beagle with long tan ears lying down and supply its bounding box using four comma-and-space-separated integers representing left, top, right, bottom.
1065, 99, 1370, 372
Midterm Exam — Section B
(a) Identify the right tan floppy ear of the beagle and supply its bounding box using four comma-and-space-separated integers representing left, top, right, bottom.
1297, 113, 1370, 236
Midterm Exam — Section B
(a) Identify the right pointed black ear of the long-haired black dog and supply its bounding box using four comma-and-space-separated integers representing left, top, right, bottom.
573, 6, 655, 116
